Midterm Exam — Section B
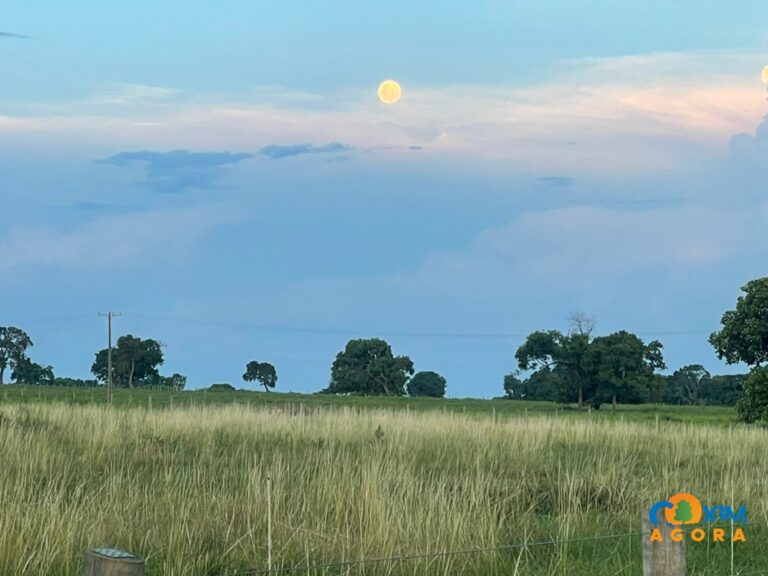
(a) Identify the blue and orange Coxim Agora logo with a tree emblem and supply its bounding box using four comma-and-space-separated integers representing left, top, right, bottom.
648, 492, 747, 542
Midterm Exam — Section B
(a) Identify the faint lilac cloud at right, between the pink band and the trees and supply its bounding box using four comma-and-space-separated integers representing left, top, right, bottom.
400, 205, 756, 296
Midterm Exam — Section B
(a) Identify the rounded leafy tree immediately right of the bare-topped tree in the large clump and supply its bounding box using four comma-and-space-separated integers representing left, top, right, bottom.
588, 330, 666, 409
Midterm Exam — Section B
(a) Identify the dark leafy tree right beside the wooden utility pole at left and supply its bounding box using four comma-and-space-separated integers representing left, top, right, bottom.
91, 334, 164, 388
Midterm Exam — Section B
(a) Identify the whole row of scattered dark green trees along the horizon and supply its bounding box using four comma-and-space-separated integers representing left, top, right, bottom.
0, 278, 768, 422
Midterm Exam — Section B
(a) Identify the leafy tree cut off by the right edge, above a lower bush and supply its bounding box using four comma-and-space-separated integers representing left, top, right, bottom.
709, 277, 768, 366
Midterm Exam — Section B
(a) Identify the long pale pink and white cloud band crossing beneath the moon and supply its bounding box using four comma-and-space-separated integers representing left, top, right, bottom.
0, 52, 765, 173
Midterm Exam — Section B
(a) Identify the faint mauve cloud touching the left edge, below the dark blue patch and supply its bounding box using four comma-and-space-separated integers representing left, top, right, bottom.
0, 204, 239, 272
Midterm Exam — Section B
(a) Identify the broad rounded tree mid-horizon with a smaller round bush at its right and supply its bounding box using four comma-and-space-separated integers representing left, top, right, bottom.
325, 338, 413, 396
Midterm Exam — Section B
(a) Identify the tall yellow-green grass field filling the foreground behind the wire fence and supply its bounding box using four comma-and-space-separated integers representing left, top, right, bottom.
0, 387, 768, 576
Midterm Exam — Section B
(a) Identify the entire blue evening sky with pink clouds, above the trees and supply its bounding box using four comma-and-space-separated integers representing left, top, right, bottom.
0, 0, 768, 397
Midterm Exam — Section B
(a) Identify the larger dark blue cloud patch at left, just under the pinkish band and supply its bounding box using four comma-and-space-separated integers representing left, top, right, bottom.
97, 150, 253, 192
